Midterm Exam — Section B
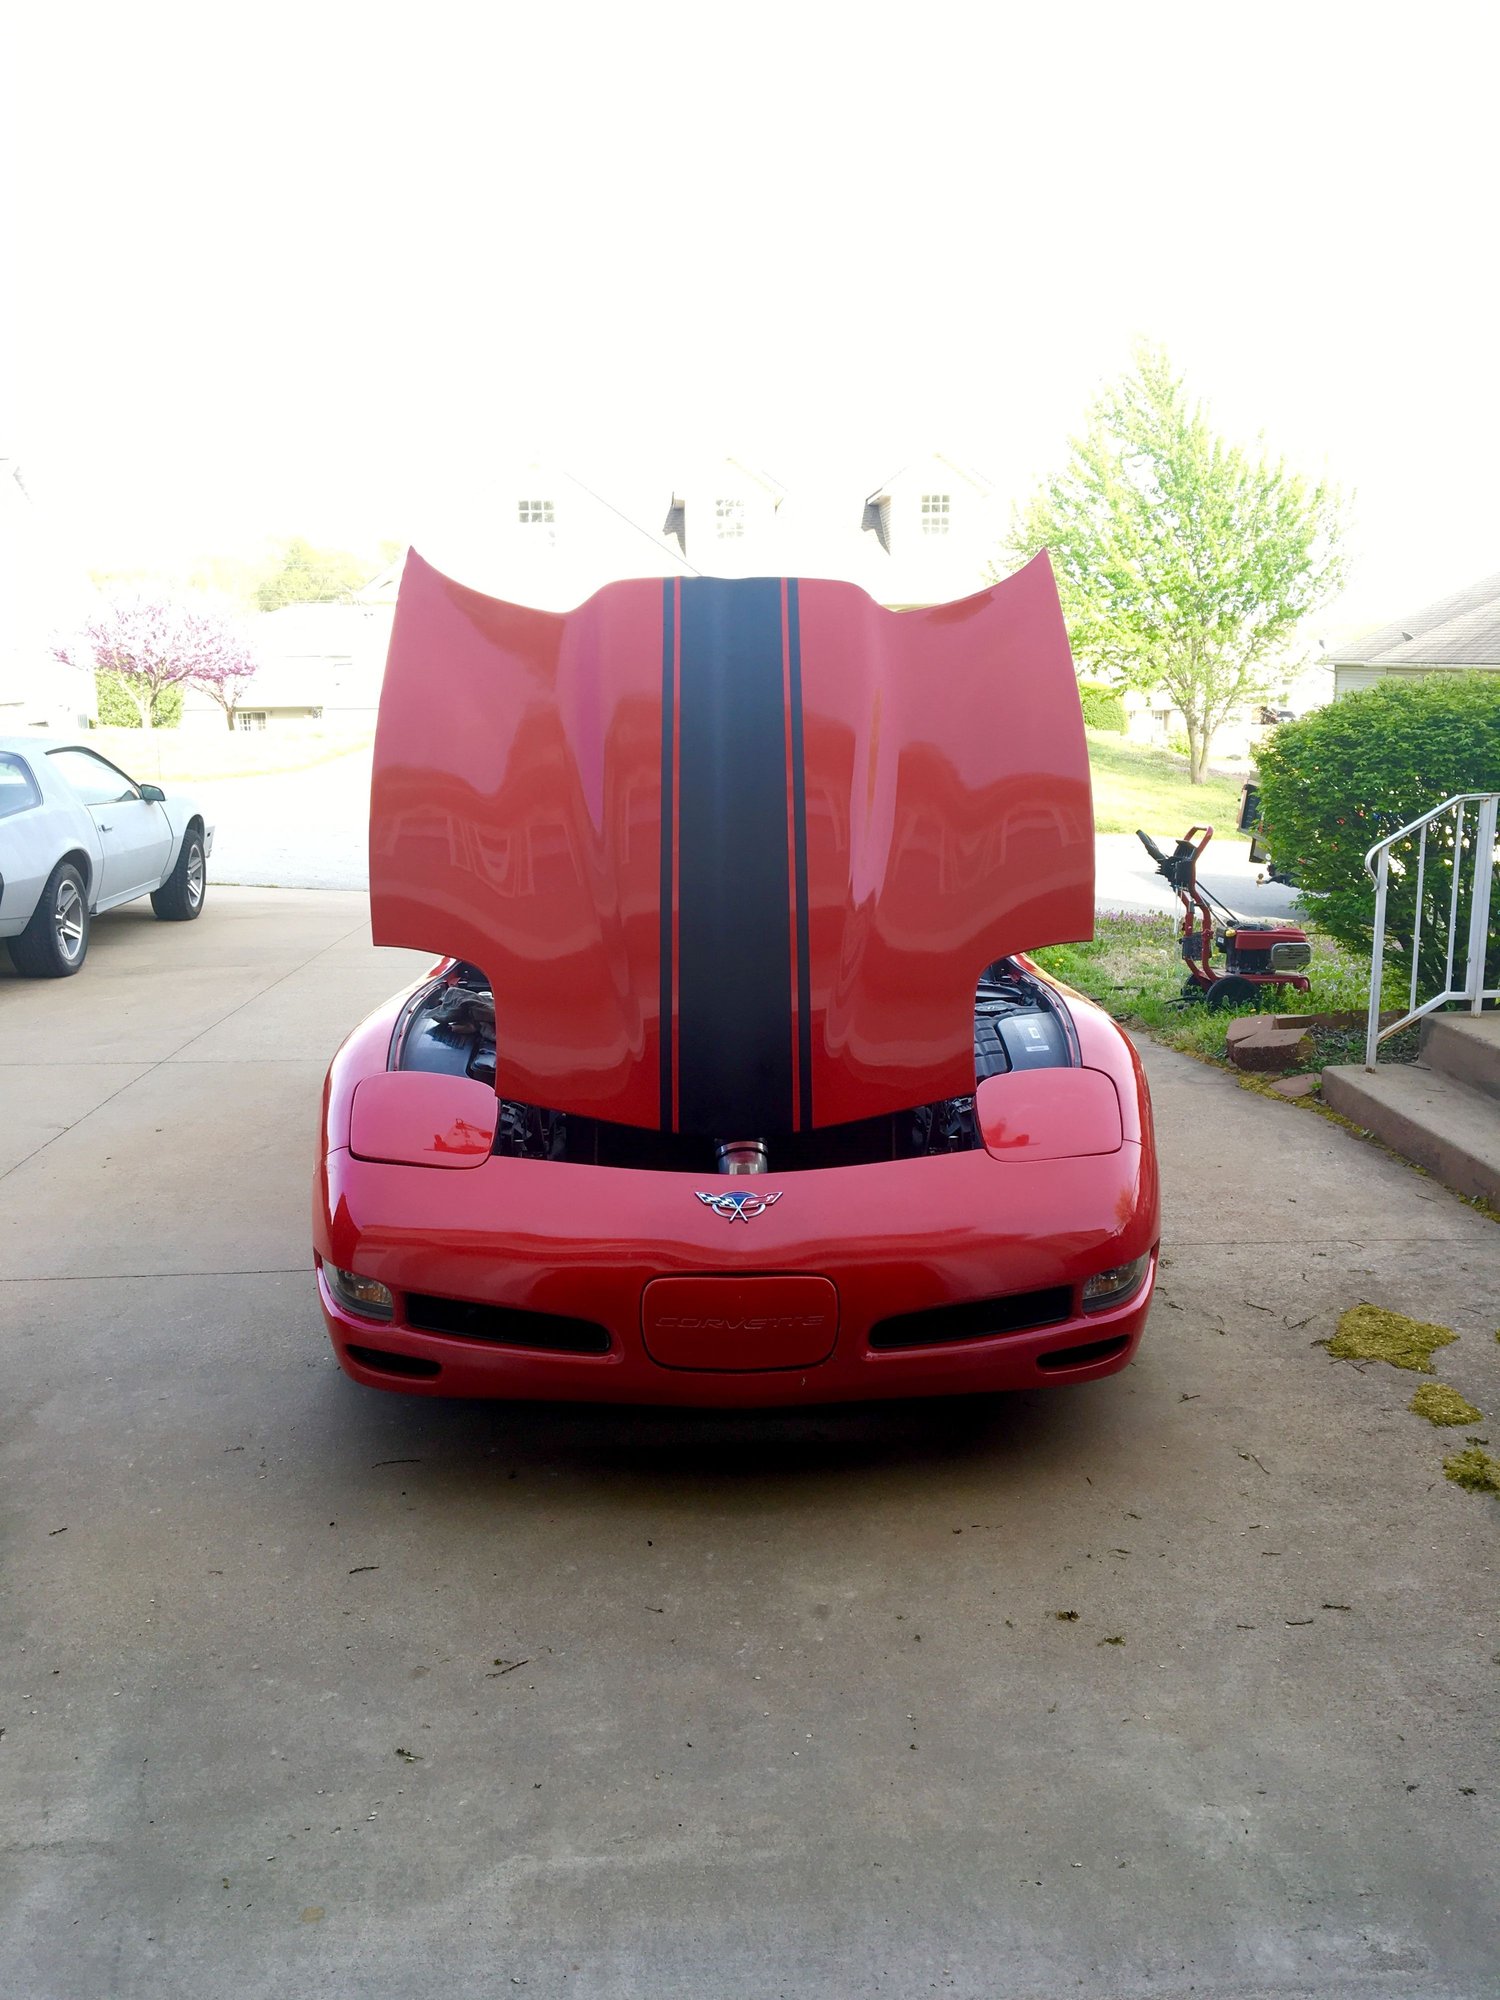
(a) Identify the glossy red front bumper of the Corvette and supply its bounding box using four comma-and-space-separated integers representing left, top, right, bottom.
314, 1142, 1158, 1408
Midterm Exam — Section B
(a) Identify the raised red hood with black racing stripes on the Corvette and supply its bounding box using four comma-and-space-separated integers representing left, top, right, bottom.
370, 554, 1094, 1140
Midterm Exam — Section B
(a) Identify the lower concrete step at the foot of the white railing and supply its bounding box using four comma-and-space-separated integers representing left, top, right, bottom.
1322, 1062, 1500, 1204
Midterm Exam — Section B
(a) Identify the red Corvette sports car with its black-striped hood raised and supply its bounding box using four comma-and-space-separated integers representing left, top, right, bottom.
314, 554, 1158, 1406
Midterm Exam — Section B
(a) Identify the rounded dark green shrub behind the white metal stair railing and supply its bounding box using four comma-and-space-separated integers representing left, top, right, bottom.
1260, 672, 1500, 992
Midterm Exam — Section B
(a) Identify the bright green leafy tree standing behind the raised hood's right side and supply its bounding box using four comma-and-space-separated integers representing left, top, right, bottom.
1012, 344, 1342, 784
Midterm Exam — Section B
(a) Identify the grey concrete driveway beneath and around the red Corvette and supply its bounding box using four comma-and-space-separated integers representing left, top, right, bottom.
0, 888, 1500, 2000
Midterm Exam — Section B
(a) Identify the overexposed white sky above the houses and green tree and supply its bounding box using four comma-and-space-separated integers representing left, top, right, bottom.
0, 0, 1500, 620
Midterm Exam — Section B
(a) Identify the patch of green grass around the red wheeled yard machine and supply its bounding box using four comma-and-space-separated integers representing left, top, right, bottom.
1032, 912, 1416, 1070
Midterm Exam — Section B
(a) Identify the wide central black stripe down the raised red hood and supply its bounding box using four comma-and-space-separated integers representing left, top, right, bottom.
676, 576, 794, 1140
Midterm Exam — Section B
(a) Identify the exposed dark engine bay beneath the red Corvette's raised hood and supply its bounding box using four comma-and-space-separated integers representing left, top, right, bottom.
388, 958, 1078, 1174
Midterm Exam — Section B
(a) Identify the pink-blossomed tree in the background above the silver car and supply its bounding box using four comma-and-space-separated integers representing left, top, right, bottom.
52, 596, 256, 730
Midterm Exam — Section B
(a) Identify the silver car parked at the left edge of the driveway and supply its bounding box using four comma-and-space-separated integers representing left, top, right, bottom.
0, 736, 214, 980
